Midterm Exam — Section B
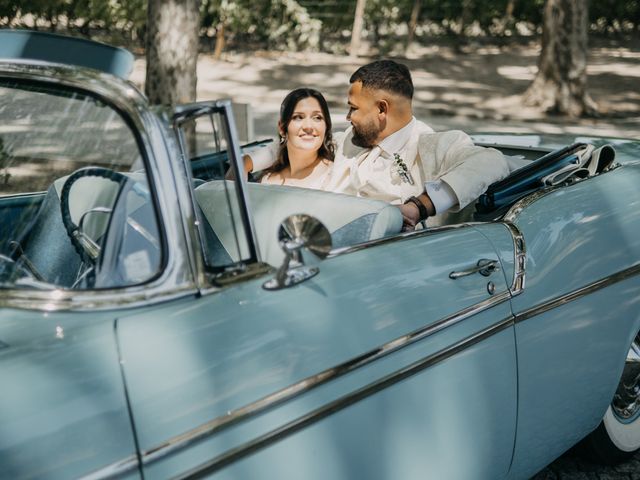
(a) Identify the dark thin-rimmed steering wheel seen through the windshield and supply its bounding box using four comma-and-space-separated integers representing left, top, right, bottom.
60, 167, 149, 266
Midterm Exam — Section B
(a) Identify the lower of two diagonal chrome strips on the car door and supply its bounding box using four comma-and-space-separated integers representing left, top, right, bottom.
174, 317, 513, 480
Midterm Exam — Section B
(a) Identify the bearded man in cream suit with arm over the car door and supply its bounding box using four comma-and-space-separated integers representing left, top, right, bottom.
252, 60, 509, 230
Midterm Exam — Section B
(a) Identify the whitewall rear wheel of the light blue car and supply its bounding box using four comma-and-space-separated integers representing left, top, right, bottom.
584, 333, 640, 465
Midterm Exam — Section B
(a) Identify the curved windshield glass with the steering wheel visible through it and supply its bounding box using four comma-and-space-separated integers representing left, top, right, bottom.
0, 80, 161, 289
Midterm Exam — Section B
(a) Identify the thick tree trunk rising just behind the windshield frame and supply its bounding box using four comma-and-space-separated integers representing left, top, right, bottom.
145, 0, 200, 106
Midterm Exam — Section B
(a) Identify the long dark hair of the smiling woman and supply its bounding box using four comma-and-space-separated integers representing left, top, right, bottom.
266, 88, 335, 173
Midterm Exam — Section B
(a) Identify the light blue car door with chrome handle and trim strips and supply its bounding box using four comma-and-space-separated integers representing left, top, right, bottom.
117, 103, 517, 479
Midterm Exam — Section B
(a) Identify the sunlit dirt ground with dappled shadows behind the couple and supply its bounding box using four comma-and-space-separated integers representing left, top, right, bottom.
132, 41, 640, 139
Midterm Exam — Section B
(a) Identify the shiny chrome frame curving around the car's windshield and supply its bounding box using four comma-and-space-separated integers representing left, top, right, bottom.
0, 61, 197, 311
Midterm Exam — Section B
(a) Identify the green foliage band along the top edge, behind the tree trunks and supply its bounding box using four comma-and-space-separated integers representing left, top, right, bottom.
0, 0, 640, 50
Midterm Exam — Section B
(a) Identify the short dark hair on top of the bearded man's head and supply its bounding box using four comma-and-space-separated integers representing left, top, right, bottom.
349, 60, 413, 100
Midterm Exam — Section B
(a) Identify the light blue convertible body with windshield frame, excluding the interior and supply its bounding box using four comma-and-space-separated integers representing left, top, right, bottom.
0, 31, 640, 479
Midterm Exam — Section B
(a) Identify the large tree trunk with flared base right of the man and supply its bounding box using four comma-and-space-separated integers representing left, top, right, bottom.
524, 0, 597, 117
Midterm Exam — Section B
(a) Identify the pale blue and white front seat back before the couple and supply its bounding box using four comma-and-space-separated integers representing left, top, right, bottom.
195, 180, 402, 265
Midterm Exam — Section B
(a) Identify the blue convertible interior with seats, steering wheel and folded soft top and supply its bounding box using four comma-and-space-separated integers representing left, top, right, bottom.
0, 115, 615, 289
